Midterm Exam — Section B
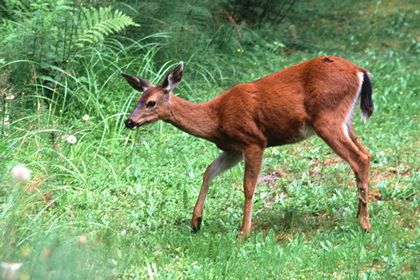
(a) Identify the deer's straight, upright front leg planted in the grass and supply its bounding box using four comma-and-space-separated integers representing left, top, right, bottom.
239, 145, 264, 239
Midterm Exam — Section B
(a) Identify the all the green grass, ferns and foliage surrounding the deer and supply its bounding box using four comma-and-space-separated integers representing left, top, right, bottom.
0, 0, 420, 279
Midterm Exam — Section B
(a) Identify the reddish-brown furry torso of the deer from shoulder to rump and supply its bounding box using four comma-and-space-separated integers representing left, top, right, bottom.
209, 57, 363, 150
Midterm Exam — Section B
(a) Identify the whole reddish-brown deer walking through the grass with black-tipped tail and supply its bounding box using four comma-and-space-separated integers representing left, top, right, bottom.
121, 56, 373, 236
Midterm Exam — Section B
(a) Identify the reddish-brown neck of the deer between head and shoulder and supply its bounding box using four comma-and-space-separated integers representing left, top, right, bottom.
165, 95, 218, 141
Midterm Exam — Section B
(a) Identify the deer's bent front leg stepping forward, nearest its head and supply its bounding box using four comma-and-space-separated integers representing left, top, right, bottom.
191, 152, 242, 232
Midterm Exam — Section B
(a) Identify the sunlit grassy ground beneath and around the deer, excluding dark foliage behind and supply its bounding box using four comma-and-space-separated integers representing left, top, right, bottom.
0, 1, 420, 279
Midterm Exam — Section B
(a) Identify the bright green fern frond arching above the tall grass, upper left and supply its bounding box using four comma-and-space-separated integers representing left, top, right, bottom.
76, 7, 139, 47
